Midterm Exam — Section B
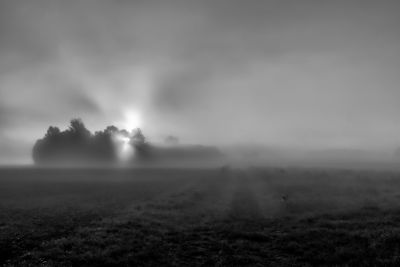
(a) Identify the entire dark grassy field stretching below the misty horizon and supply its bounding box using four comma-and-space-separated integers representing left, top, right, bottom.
0, 168, 400, 266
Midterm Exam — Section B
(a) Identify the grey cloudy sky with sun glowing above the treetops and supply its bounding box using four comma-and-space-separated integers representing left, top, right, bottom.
0, 0, 400, 163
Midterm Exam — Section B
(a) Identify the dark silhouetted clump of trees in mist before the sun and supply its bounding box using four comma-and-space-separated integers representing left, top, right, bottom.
32, 119, 221, 165
